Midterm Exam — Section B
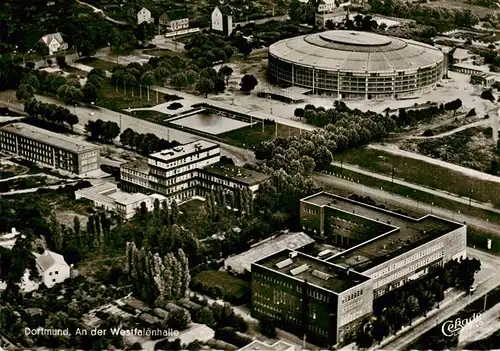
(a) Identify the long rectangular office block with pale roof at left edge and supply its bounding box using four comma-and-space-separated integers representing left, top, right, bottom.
0, 123, 100, 175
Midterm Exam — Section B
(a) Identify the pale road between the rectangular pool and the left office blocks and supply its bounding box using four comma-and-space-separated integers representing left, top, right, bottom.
32, 95, 255, 165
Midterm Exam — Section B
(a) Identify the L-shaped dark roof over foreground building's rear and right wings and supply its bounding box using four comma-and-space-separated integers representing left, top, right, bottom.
301, 192, 464, 272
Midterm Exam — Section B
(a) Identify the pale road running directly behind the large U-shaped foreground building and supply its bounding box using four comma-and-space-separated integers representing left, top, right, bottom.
313, 173, 500, 235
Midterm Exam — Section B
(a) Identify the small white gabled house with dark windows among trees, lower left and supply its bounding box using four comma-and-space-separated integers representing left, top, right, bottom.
36, 250, 71, 288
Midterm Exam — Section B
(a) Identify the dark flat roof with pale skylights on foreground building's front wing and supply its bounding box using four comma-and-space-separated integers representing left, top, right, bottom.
254, 250, 370, 293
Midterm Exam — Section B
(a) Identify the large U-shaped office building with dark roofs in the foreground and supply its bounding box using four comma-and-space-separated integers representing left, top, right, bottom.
252, 193, 467, 346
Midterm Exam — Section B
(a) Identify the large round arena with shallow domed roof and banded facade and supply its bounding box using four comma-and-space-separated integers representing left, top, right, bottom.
269, 30, 445, 99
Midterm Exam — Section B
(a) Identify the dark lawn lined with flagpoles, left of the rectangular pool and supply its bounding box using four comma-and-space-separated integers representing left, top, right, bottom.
96, 80, 165, 112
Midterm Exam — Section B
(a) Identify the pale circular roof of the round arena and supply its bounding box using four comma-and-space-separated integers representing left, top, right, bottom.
269, 30, 443, 72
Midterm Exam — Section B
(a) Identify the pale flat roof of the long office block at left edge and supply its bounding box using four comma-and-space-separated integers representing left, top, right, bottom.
0, 123, 99, 153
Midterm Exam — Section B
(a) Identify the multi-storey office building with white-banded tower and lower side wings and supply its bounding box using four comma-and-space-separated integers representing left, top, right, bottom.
120, 140, 269, 201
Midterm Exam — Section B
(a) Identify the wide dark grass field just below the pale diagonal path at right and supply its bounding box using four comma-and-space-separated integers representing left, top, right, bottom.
334, 148, 500, 207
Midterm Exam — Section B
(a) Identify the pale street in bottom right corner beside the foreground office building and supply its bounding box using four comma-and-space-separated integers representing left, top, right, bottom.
376, 248, 500, 351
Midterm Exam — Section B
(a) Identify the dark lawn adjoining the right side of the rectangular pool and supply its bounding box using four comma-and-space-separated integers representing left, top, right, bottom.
217, 122, 301, 149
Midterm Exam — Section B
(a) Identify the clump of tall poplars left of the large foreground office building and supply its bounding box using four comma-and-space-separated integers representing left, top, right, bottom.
125, 242, 191, 306
